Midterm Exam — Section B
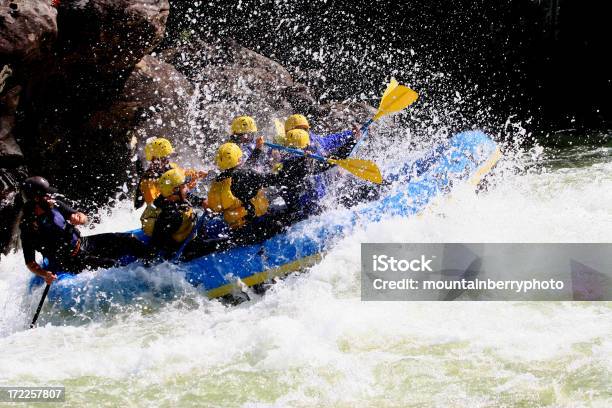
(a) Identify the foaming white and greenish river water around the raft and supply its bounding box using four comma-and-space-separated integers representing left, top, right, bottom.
0, 142, 612, 407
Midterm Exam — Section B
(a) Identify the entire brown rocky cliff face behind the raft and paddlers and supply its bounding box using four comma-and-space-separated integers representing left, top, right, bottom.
0, 0, 372, 255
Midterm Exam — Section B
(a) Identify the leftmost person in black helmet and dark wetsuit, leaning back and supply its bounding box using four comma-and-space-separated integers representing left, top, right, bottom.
19, 176, 149, 284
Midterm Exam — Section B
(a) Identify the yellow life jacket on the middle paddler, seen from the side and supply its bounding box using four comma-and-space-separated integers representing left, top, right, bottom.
208, 177, 270, 229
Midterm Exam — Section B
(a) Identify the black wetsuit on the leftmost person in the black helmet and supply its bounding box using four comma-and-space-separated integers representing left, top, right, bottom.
19, 200, 148, 273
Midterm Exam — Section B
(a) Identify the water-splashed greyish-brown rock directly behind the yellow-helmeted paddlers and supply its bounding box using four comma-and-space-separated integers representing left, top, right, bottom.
163, 41, 294, 150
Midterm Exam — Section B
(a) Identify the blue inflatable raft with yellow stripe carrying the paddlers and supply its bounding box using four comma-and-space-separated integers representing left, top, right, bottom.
30, 131, 501, 308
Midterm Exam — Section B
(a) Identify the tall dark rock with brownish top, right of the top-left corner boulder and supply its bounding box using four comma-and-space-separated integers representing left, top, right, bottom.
16, 0, 169, 203
